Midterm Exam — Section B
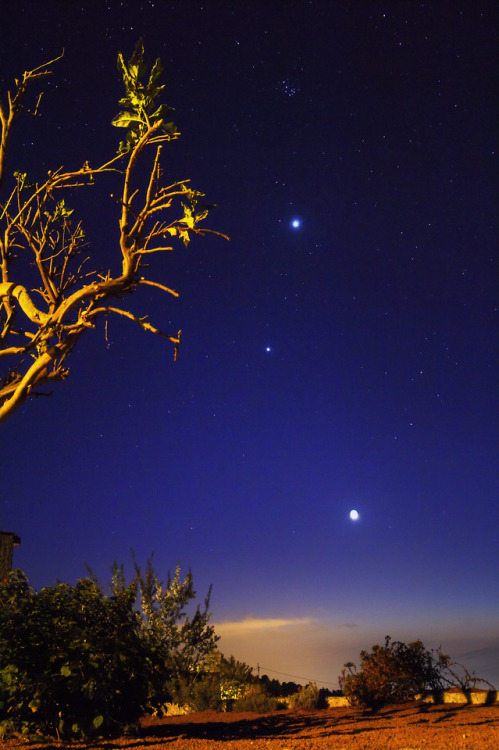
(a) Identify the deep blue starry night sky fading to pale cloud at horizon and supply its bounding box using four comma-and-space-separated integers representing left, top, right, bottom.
0, 0, 499, 687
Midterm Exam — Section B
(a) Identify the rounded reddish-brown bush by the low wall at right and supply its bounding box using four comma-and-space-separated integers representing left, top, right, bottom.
339, 636, 449, 708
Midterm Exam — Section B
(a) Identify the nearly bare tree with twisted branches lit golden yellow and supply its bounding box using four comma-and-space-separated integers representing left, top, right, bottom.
0, 40, 225, 422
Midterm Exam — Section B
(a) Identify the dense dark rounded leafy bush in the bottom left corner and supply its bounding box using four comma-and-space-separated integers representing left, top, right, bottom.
0, 571, 148, 737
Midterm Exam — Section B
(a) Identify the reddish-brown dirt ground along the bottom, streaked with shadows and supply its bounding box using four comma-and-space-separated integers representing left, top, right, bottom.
2, 704, 499, 750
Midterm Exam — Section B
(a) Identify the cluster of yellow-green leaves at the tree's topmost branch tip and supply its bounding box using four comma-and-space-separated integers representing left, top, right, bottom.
111, 39, 177, 154
